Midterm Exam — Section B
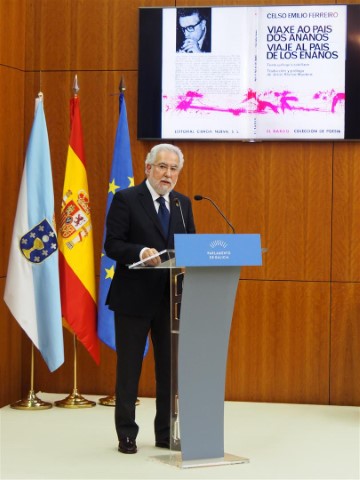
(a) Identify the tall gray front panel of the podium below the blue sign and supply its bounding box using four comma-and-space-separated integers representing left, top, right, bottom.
178, 267, 240, 462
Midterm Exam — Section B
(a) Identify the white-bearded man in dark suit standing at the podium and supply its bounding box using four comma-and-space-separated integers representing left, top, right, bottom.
105, 144, 195, 453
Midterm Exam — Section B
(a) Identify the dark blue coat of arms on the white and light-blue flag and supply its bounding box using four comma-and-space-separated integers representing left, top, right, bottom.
20, 218, 58, 263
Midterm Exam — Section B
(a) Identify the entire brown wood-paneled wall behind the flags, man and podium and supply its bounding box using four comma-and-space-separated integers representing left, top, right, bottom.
0, 0, 360, 405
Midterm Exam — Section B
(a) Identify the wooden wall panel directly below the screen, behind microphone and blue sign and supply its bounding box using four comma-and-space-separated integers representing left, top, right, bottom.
183, 142, 332, 281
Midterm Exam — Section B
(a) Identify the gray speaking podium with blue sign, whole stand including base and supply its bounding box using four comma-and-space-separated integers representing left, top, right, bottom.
131, 234, 262, 468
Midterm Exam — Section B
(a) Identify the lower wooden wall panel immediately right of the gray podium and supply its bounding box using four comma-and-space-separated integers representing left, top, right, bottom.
226, 280, 330, 404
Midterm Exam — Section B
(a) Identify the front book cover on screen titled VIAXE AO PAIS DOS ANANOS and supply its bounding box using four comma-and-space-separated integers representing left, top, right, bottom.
256, 5, 346, 139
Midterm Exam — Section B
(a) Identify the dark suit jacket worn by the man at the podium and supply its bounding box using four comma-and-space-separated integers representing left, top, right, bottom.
105, 181, 195, 316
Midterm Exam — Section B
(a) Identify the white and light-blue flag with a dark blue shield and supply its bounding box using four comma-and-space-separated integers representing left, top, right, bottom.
4, 94, 64, 372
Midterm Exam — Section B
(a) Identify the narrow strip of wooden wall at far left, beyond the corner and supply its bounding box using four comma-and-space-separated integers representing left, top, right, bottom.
0, 0, 25, 406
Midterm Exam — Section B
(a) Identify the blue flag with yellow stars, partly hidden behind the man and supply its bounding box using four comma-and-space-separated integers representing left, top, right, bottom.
98, 93, 134, 350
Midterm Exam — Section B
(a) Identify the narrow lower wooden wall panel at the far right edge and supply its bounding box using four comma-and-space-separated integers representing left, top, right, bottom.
330, 283, 360, 406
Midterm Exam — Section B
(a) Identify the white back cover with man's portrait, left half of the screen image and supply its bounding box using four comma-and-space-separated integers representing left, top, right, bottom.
162, 7, 256, 139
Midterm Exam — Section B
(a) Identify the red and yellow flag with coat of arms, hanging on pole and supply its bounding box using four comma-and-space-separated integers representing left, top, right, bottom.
58, 96, 100, 363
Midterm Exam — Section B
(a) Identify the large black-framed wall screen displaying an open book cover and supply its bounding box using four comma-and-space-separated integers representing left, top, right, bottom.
138, 5, 360, 141
